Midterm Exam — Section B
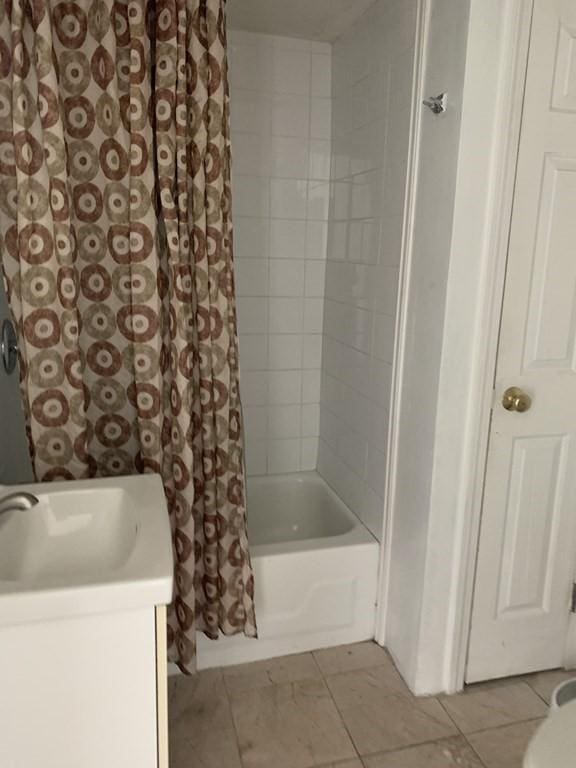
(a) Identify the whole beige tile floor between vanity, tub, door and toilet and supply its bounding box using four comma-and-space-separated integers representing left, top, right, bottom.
169, 643, 574, 768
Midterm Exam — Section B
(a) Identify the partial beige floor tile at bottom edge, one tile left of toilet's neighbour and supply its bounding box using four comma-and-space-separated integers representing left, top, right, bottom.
364, 736, 483, 768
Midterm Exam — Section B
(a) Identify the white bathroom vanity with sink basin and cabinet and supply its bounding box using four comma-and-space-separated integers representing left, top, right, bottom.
0, 475, 173, 768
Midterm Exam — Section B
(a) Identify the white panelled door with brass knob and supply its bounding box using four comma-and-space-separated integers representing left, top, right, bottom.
466, 0, 576, 682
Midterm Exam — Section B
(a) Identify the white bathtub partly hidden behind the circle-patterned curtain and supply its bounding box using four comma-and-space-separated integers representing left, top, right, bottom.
198, 472, 380, 669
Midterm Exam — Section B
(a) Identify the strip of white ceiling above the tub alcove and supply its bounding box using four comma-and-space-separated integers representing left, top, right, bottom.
227, 0, 374, 42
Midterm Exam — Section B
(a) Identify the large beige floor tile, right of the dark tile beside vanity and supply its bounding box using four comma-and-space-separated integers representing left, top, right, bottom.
231, 680, 356, 768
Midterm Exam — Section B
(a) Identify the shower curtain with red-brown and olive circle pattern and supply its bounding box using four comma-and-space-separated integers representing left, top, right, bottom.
0, 0, 256, 671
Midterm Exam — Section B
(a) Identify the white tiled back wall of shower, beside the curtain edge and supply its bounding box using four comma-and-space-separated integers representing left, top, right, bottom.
229, 32, 331, 474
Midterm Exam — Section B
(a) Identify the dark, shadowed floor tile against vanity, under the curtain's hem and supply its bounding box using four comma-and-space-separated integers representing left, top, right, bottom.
168, 669, 234, 744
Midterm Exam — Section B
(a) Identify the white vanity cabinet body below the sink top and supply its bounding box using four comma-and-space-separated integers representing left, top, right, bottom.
0, 607, 168, 768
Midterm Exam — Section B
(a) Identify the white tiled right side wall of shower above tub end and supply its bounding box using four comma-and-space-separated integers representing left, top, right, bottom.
318, 0, 417, 538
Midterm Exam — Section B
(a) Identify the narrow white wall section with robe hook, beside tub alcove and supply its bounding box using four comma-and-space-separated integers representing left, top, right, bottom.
385, 0, 476, 694
